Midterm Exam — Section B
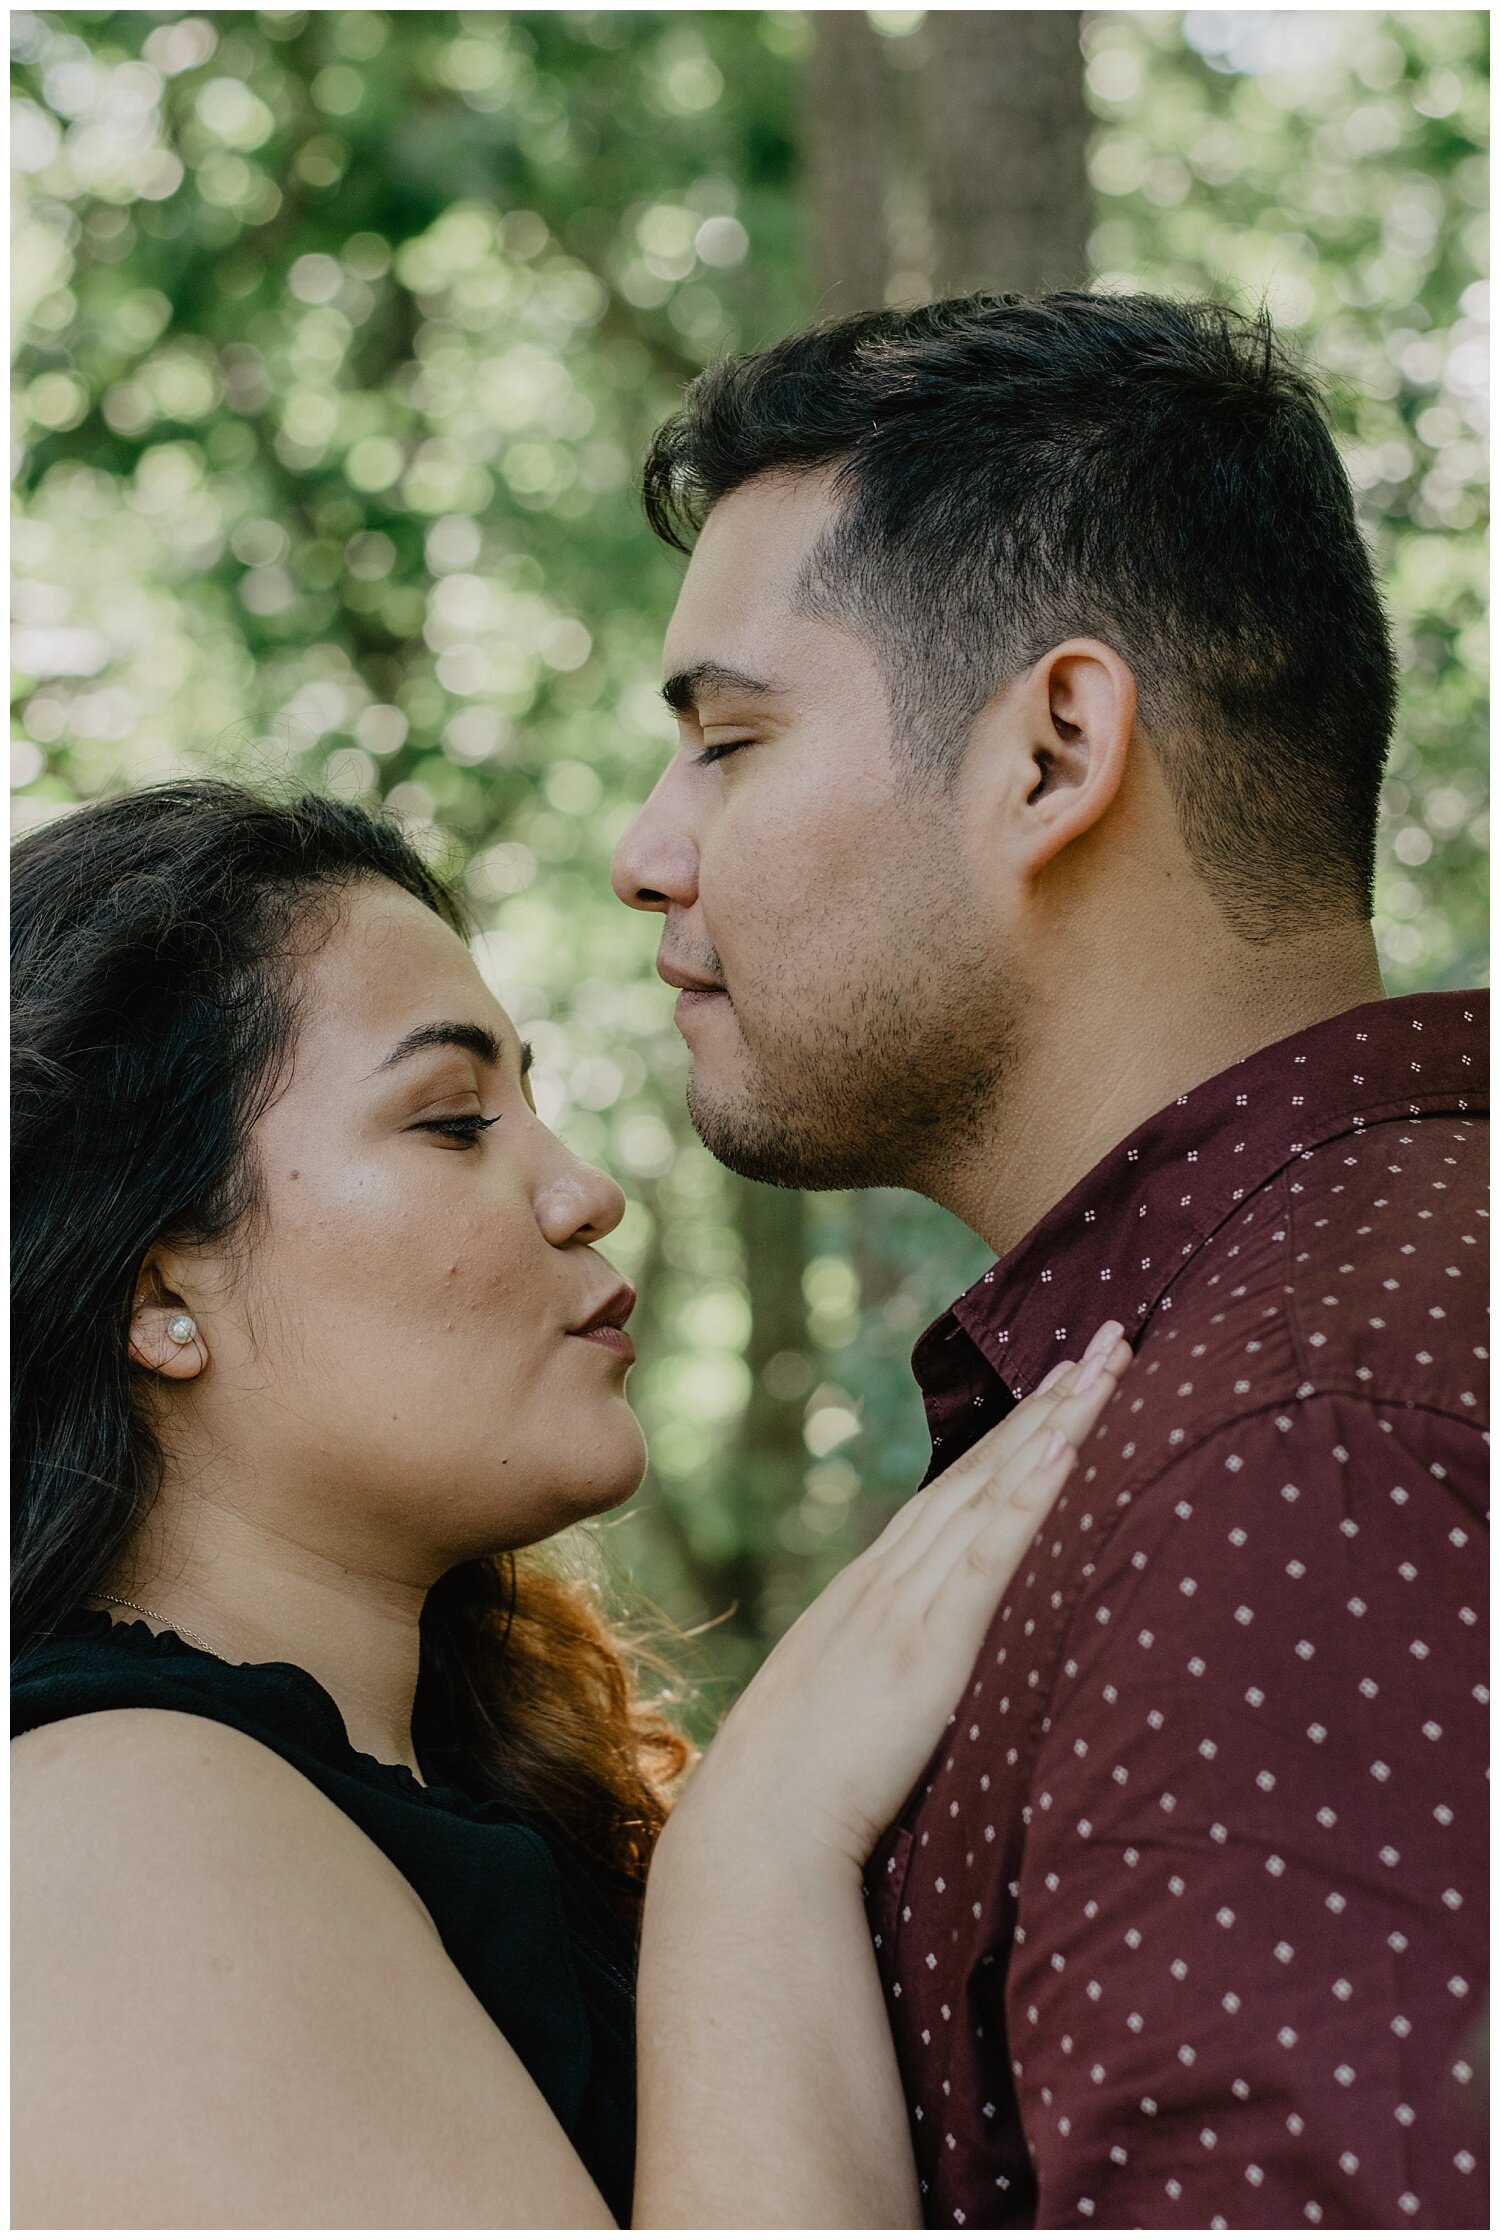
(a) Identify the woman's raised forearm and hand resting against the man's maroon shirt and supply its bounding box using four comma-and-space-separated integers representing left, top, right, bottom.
634, 1324, 1131, 2231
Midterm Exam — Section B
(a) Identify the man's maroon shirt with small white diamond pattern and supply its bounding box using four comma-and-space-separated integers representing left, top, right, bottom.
866, 995, 1487, 2229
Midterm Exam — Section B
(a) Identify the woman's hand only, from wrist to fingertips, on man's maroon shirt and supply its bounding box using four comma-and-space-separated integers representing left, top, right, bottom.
663, 1322, 1131, 1873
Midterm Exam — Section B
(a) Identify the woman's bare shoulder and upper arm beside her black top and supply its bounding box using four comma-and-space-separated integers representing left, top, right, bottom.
11, 1709, 609, 2229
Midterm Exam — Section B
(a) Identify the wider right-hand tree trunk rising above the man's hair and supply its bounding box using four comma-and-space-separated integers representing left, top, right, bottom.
918, 9, 1088, 296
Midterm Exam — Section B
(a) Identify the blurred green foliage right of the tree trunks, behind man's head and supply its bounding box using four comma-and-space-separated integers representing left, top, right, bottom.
1086, 9, 1489, 990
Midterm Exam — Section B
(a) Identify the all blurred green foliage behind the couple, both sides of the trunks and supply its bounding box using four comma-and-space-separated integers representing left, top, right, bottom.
11, 9, 1487, 1711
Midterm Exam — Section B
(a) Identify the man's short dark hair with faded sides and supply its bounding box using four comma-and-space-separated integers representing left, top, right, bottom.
645, 293, 1395, 939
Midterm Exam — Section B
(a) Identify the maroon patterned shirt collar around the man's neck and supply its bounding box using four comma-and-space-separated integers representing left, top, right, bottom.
911, 990, 1489, 1429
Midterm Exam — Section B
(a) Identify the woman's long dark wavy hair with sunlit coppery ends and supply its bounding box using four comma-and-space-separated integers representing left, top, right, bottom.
11, 782, 687, 1913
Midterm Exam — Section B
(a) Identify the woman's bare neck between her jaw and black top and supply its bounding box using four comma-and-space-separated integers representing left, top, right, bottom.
87, 1494, 425, 1779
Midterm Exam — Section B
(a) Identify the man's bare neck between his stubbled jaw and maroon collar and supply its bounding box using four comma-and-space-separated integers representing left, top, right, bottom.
927, 927, 1386, 1259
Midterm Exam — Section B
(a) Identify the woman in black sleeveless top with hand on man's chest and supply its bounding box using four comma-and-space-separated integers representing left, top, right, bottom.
11, 784, 1128, 2227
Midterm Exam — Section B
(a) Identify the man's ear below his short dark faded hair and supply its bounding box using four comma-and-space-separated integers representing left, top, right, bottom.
981, 638, 1135, 874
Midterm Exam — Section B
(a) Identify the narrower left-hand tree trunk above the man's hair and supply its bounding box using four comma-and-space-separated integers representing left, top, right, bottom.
801, 9, 889, 318
